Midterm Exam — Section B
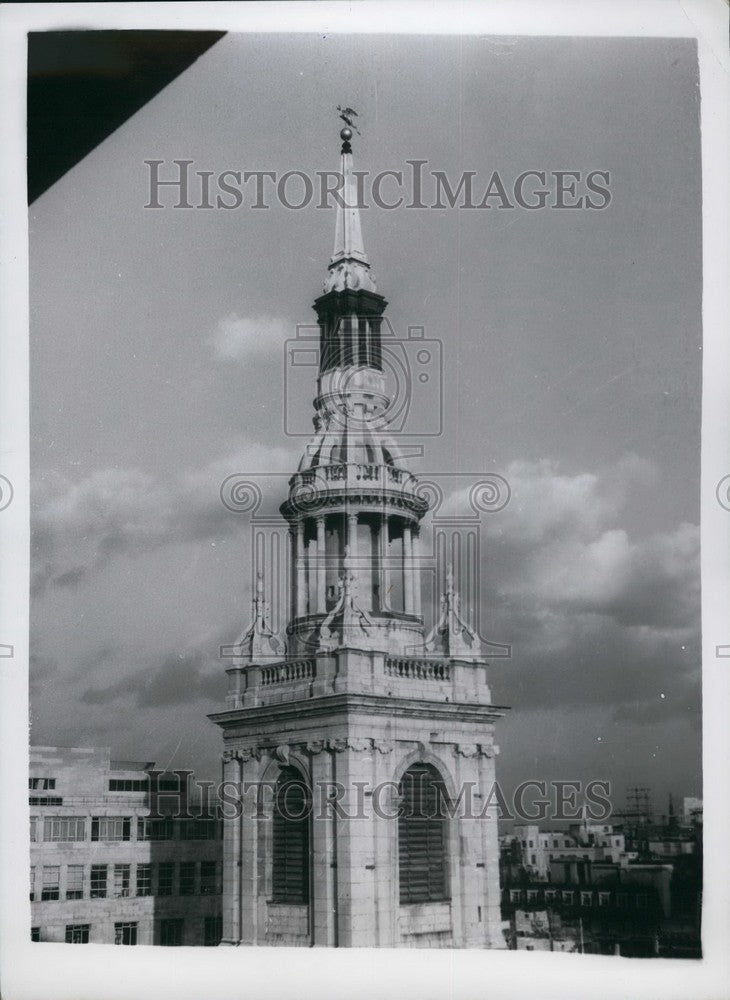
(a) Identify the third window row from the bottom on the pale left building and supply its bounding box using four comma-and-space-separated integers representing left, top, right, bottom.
30, 816, 221, 843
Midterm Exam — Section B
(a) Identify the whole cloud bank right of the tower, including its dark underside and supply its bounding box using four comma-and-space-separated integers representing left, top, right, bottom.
438, 456, 700, 721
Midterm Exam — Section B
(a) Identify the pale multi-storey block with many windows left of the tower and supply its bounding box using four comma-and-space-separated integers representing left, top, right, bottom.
29, 747, 222, 945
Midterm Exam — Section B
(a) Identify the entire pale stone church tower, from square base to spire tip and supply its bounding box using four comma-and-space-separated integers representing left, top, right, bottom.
211, 129, 505, 948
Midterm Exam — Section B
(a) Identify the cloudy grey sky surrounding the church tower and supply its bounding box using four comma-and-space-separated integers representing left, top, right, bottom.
30, 35, 701, 811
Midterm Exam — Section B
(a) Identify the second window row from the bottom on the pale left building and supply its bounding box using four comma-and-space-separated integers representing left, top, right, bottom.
30, 861, 221, 902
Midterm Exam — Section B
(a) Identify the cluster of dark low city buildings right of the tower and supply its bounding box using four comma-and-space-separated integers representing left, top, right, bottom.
500, 808, 702, 958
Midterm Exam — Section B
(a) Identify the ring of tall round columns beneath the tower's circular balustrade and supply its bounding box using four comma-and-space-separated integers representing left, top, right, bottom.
289, 512, 421, 618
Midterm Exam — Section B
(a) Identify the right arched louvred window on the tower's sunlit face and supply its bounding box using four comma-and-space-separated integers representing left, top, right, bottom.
398, 764, 450, 903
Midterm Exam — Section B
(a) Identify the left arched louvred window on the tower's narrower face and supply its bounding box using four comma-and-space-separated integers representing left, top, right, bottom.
272, 767, 312, 903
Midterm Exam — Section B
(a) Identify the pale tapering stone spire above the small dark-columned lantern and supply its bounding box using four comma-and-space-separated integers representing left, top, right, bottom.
324, 127, 375, 292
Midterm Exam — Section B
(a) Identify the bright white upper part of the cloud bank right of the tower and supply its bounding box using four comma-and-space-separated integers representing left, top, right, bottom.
472, 456, 699, 627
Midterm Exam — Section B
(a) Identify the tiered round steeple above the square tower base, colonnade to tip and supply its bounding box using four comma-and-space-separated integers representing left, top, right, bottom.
281, 119, 428, 655
